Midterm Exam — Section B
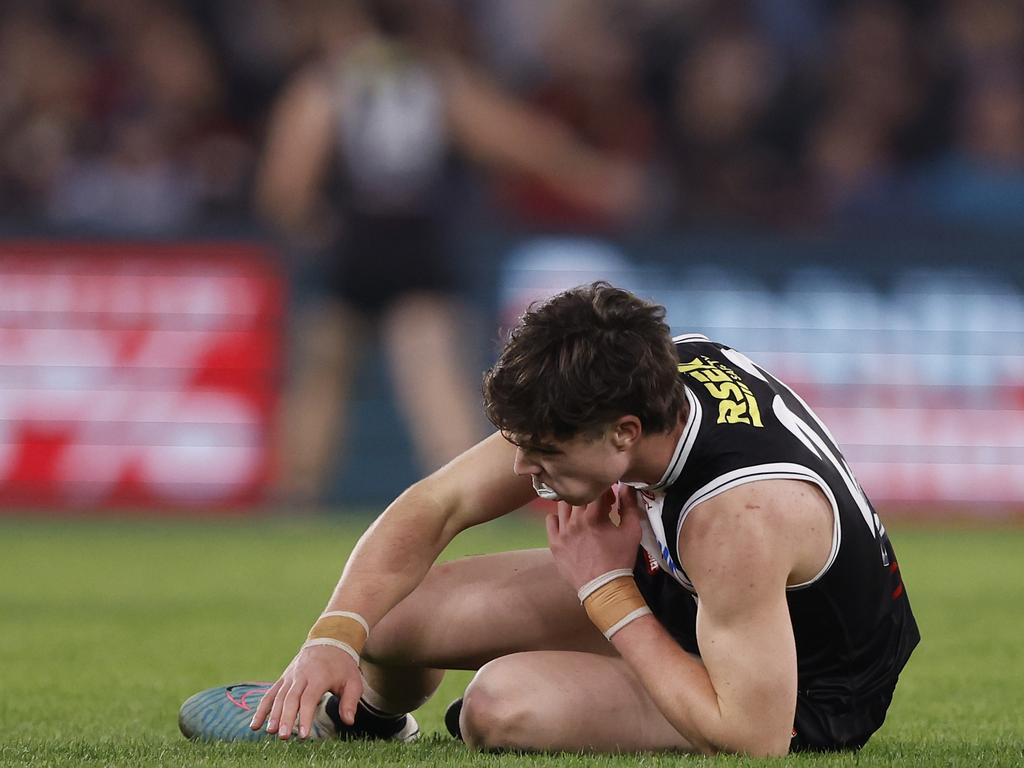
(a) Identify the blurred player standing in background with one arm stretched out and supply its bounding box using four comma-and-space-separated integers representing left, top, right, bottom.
258, 0, 639, 500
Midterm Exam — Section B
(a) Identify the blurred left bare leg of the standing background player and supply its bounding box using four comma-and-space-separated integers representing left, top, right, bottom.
278, 302, 365, 501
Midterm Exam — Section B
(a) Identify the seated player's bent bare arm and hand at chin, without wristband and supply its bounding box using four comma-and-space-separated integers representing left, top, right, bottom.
548, 481, 830, 755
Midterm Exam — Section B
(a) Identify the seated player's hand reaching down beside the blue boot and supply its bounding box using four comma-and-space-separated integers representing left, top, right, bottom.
250, 645, 362, 739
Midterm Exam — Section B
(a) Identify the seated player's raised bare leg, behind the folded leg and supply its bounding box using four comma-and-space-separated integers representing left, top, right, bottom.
364, 549, 614, 712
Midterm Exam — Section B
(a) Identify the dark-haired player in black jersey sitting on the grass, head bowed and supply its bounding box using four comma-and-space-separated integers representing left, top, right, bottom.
181, 283, 920, 755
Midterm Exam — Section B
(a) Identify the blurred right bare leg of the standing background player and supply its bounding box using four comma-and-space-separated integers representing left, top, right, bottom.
383, 293, 482, 471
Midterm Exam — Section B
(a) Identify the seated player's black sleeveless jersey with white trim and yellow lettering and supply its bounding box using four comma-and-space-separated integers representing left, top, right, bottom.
638, 335, 920, 710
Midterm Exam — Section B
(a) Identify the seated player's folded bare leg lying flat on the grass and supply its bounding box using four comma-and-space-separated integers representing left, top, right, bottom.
459, 651, 693, 752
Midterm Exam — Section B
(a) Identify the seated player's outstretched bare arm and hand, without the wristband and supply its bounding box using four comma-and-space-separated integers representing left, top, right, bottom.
252, 434, 536, 738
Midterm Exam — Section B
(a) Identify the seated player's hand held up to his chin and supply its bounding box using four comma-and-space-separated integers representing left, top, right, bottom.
546, 485, 640, 590
